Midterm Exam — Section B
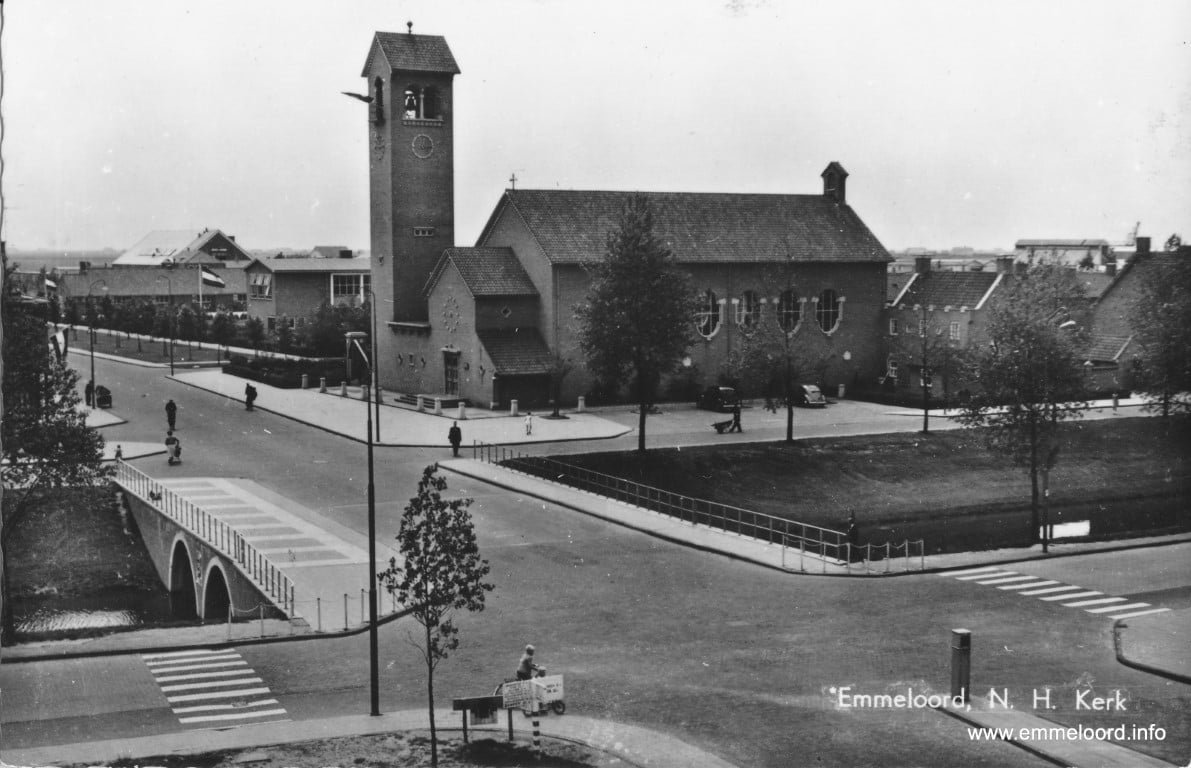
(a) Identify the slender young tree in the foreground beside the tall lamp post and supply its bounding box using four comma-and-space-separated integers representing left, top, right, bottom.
378, 464, 493, 766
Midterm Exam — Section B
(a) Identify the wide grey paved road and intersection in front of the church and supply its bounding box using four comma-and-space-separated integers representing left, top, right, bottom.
2, 363, 1191, 767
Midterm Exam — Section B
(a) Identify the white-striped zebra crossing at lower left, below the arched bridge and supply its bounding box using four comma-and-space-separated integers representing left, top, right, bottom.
141, 649, 288, 728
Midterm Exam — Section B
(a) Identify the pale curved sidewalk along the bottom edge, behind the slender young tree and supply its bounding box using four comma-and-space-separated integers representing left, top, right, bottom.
4, 708, 734, 768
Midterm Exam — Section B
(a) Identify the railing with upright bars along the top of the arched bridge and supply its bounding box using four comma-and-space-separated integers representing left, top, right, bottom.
116, 461, 295, 616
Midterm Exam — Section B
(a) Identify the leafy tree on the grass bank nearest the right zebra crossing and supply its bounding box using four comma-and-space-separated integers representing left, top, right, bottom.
958, 264, 1087, 551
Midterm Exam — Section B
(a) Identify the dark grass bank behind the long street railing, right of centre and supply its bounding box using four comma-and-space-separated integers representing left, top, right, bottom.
521, 418, 1191, 552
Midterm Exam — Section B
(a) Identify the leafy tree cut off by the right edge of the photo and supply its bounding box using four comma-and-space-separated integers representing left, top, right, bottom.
1129, 254, 1191, 416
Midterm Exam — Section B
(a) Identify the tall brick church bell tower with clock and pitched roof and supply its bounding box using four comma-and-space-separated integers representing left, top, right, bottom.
362, 24, 459, 326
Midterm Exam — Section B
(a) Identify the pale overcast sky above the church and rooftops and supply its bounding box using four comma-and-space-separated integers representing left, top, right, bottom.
0, 0, 1191, 250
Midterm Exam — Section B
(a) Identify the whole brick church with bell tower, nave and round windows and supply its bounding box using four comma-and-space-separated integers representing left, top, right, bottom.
362, 29, 892, 408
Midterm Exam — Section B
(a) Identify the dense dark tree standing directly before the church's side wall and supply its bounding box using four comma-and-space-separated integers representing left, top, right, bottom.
575, 195, 696, 451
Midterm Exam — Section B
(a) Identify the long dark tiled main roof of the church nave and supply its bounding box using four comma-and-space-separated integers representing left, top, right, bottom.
479, 189, 893, 264
